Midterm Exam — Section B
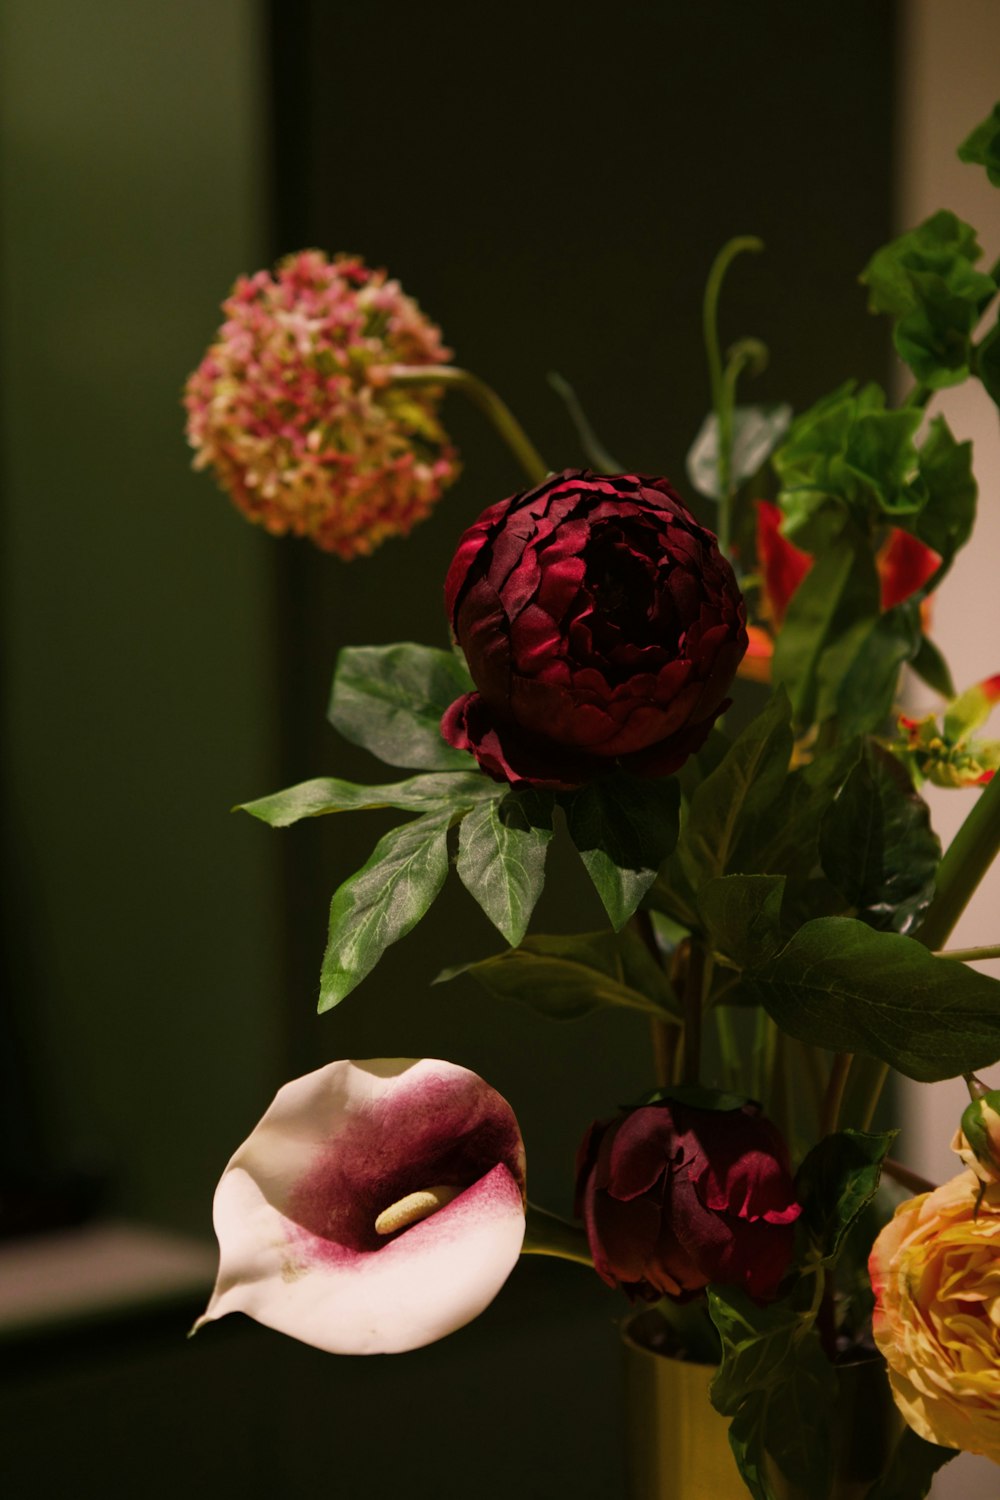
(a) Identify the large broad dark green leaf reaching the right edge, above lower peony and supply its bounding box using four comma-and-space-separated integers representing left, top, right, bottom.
744, 917, 1000, 1083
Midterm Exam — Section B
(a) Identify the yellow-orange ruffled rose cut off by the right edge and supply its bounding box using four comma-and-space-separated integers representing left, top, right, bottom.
868, 1172, 1000, 1463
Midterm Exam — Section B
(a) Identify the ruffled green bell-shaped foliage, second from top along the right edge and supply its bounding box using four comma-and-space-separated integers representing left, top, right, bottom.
861, 210, 996, 390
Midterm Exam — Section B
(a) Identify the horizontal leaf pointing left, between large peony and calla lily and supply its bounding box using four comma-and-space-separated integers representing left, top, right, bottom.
438, 927, 681, 1020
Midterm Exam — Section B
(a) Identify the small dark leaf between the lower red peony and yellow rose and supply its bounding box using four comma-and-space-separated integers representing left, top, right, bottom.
795, 1130, 897, 1266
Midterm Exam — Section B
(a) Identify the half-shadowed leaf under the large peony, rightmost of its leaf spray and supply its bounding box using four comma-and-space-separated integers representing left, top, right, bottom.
565, 771, 681, 932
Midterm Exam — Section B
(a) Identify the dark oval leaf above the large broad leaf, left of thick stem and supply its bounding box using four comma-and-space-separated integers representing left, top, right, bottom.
820, 741, 942, 933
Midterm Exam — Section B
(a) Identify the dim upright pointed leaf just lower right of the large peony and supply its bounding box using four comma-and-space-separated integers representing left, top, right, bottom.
678, 690, 792, 893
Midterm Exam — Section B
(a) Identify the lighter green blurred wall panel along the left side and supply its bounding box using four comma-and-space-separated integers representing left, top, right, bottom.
0, 0, 279, 1233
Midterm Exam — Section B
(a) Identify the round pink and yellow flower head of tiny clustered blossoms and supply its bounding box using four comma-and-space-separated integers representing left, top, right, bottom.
184, 251, 459, 558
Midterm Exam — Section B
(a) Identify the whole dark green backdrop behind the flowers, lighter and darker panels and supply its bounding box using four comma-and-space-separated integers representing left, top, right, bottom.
0, 0, 892, 1500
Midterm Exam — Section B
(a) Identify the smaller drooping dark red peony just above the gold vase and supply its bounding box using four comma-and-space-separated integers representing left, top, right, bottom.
576, 1100, 801, 1302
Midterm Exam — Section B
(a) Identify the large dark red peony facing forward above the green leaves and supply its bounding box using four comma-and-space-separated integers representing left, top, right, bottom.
441, 470, 747, 791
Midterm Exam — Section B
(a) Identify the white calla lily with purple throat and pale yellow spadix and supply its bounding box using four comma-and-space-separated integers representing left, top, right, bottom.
195, 1058, 525, 1355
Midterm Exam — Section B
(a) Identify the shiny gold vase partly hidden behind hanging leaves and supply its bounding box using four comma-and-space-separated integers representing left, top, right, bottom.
625, 1314, 903, 1500
